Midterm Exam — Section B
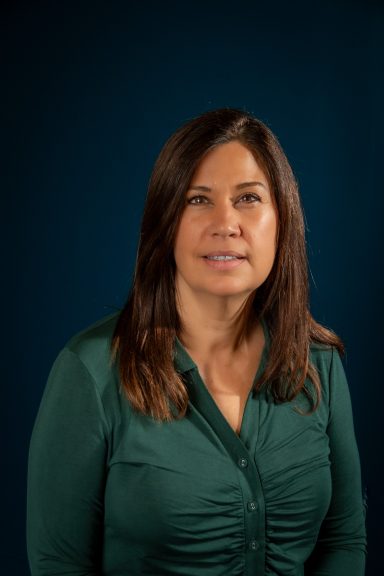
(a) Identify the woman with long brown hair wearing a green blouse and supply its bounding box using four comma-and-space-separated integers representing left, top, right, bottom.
28, 109, 365, 576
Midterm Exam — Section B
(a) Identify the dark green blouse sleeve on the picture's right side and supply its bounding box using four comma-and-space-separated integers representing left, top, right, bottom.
305, 350, 366, 576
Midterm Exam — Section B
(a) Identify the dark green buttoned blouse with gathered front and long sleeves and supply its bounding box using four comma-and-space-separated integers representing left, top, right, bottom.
27, 317, 365, 576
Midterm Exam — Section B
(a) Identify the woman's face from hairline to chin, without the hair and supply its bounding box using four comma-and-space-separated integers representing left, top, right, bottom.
174, 141, 278, 303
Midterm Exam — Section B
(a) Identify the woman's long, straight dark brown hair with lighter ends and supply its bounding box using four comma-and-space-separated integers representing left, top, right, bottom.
112, 108, 343, 421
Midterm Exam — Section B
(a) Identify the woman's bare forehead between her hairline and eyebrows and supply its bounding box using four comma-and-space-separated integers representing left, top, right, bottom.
192, 141, 266, 183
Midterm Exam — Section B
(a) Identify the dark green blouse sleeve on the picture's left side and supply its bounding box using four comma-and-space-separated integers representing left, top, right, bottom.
27, 349, 107, 576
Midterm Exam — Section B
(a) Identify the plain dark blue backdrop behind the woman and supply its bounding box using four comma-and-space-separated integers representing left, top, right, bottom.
0, 0, 384, 576
